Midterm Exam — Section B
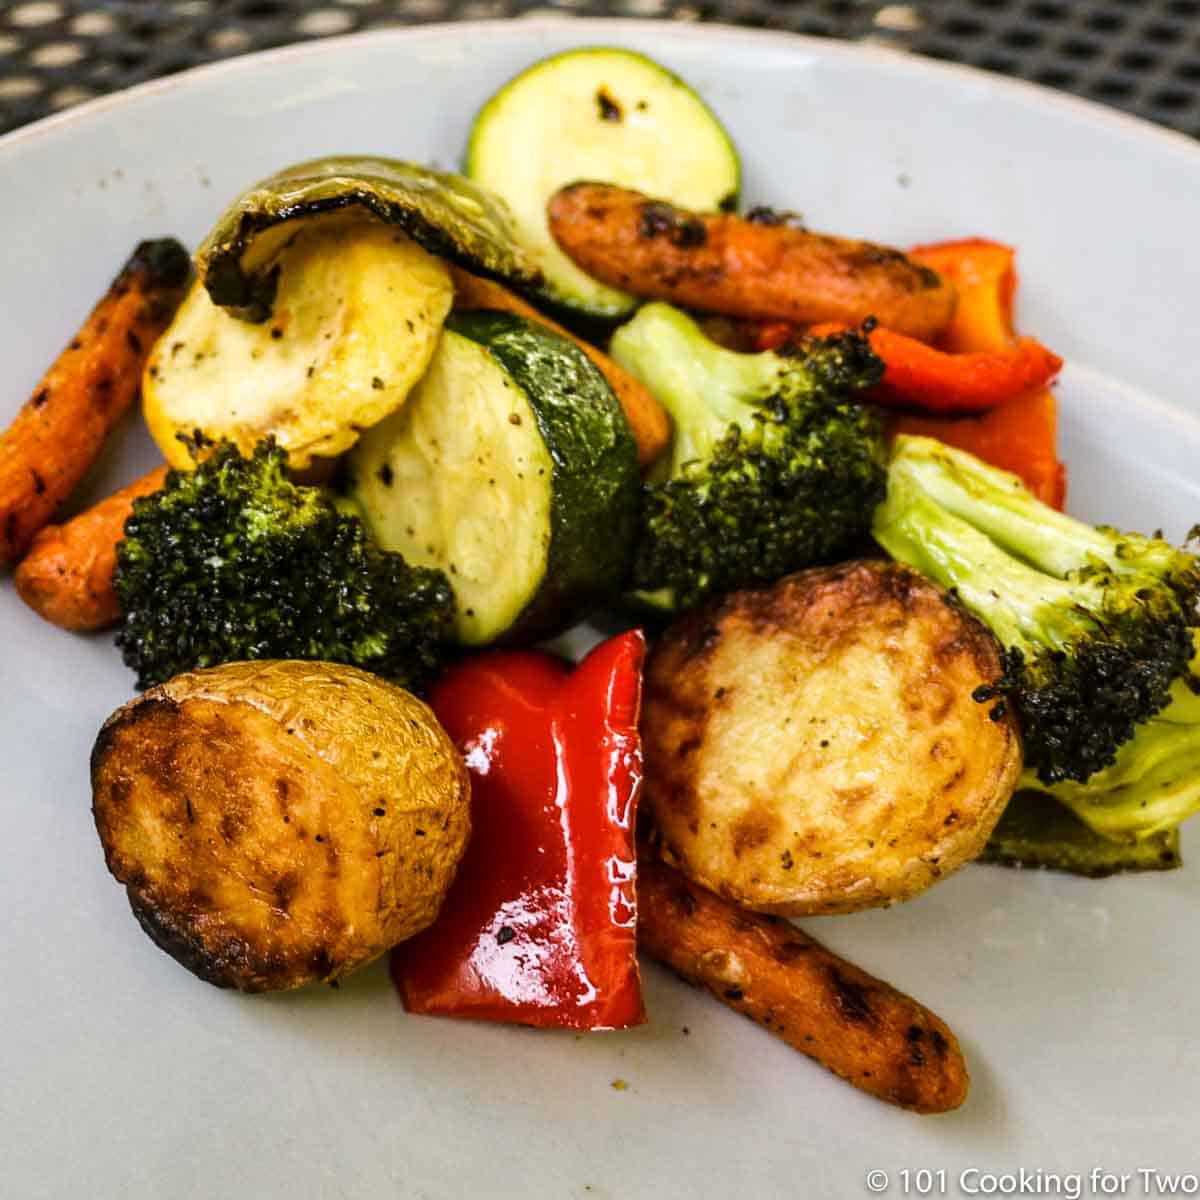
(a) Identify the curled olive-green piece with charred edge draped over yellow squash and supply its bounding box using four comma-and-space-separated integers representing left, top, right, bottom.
197, 155, 541, 322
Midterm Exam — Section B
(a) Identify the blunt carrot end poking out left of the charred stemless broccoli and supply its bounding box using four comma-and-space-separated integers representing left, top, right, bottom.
13, 467, 167, 632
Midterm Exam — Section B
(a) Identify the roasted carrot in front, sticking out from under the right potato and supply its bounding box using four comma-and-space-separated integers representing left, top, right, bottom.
637, 856, 968, 1112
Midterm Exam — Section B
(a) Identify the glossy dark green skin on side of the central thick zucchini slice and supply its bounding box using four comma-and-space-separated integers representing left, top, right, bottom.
446, 310, 641, 644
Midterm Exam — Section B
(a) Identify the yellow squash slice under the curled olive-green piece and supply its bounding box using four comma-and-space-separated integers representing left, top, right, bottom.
142, 221, 454, 468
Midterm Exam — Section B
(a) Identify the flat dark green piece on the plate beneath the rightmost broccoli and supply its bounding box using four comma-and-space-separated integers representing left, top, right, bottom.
979, 790, 1183, 880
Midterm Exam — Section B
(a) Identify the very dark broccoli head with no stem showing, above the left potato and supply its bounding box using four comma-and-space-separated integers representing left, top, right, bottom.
113, 440, 455, 689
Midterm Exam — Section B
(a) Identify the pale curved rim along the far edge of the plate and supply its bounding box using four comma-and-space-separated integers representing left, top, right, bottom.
7, 13, 1200, 166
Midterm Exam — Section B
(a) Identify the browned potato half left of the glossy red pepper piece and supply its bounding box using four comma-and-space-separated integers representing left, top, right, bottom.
91, 661, 470, 991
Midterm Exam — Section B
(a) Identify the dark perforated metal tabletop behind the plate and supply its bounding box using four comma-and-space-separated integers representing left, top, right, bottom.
0, 0, 1200, 137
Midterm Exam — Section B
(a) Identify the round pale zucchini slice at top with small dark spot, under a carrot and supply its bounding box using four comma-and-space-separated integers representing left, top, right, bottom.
466, 47, 740, 318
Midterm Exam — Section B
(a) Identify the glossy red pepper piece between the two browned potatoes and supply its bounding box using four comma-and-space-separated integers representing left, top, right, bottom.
391, 630, 646, 1030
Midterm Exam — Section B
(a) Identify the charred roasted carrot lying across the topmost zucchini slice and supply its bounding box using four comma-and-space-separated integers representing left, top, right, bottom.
548, 184, 955, 340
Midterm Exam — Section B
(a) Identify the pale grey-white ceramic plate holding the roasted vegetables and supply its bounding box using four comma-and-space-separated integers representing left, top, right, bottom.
0, 22, 1200, 1198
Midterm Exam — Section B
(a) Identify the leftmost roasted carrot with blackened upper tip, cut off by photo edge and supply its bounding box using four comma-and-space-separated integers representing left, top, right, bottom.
0, 238, 191, 564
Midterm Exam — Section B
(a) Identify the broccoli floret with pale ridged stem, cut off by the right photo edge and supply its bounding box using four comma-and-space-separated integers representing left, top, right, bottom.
874, 437, 1200, 784
